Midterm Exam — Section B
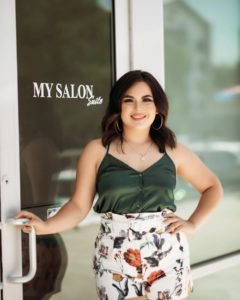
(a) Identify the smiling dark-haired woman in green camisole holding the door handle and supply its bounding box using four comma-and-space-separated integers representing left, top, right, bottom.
16, 70, 223, 300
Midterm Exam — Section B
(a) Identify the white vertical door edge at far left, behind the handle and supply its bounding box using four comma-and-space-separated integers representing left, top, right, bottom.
0, 0, 23, 300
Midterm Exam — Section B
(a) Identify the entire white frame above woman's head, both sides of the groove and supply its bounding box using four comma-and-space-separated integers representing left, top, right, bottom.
115, 0, 165, 89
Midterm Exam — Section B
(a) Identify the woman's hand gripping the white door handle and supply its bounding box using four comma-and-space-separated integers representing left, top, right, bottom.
15, 210, 48, 235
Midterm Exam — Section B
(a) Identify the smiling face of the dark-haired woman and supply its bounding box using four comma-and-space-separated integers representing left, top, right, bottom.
121, 82, 157, 129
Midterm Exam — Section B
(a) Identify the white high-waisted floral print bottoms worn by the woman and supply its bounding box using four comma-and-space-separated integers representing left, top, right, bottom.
93, 209, 194, 300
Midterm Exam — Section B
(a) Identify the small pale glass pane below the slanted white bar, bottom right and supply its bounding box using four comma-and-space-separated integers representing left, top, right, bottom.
191, 265, 240, 300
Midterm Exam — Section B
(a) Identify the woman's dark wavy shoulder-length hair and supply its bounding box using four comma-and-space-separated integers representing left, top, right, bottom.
101, 70, 176, 153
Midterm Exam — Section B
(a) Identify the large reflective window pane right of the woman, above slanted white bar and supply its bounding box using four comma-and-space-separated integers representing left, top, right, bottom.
164, 0, 240, 263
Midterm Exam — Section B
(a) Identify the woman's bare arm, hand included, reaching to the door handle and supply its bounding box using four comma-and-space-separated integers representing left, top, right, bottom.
16, 140, 97, 235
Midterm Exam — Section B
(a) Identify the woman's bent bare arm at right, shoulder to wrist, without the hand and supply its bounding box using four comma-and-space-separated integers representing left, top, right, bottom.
177, 143, 223, 231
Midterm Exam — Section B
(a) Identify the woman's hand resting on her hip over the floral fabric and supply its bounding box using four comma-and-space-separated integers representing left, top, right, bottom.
164, 213, 194, 234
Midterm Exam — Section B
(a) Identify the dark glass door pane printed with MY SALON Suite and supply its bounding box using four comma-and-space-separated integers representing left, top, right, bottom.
16, 0, 112, 300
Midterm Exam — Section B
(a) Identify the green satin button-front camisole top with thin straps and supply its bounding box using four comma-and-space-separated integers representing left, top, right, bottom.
93, 145, 176, 214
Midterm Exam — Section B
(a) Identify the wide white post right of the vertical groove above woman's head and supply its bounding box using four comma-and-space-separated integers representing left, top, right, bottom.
130, 0, 164, 88
